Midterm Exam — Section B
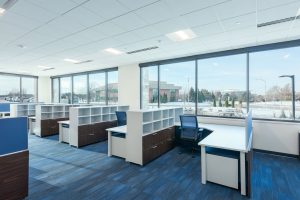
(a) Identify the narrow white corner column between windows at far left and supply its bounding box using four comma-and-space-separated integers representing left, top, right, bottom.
38, 76, 51, 103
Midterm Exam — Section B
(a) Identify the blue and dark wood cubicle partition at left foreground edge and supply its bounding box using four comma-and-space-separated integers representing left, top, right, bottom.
0, 117, 29, 199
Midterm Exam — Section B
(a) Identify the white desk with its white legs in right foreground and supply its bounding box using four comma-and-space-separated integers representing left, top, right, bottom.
199, 124, 248, 195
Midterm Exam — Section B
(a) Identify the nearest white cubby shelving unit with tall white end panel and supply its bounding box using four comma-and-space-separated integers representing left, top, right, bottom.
126, 108, 183, 165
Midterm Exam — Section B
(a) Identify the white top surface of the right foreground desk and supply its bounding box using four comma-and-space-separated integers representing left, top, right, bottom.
198, 124, 248, 152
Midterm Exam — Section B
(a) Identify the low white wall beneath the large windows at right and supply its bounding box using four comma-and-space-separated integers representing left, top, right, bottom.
198, 117, 300, 155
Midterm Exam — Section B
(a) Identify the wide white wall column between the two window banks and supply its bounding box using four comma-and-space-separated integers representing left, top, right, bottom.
118, 64, 140, 109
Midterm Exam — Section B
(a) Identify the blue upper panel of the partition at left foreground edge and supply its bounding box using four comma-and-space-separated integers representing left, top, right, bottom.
0, 117, 28, 156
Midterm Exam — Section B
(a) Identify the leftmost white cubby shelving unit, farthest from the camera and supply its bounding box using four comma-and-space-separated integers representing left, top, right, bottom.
10, 103, 39, 117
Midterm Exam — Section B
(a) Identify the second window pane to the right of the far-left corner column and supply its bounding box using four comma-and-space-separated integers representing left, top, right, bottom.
60, 77, 72, 103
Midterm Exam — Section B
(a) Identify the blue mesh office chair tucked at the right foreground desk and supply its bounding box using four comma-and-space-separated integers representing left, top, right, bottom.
180, 115, 203, 157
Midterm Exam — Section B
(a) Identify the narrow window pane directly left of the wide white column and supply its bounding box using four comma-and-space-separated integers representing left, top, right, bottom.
107, 71, 118, 104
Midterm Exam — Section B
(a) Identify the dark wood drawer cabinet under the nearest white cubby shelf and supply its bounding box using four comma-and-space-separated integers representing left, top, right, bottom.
143, 127, 175, 164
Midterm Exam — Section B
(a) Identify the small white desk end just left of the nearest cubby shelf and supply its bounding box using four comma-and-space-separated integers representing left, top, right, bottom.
106, 125, 127, 158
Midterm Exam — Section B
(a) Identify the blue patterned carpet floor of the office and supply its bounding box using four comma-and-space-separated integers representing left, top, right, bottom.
27, 135, 300, 200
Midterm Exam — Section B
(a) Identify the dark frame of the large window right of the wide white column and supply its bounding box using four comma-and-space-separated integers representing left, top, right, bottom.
139, 39, 300, 123
